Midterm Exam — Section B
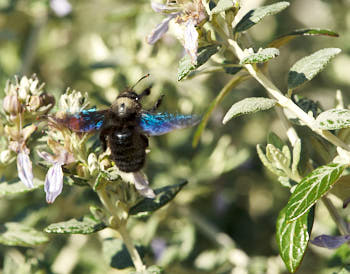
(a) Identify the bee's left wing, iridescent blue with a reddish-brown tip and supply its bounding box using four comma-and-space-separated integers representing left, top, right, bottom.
53, 108, 106, 132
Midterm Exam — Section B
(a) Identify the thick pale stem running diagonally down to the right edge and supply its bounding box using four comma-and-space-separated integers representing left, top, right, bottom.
228, 39, 350, 151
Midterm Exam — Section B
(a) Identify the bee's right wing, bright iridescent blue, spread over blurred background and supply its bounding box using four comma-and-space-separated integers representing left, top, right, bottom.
140, 112, 200, 136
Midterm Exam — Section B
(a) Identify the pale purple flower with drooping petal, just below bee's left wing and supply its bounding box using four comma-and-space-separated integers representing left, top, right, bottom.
38, 150, 73, 204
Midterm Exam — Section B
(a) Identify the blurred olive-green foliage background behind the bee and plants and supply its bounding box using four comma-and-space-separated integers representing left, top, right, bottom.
0, 0, 350, 274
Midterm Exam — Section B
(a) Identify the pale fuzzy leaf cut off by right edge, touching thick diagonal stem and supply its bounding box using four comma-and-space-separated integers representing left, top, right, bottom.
315, 109, 350, 130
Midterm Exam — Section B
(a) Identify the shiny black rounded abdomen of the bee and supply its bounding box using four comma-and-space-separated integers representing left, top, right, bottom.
109, 130, 148, 172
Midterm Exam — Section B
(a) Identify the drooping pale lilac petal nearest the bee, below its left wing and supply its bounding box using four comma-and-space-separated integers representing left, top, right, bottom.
44, 163, 63, 204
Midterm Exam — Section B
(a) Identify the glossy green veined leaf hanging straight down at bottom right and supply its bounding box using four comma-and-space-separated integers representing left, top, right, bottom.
276, 208, 314, 273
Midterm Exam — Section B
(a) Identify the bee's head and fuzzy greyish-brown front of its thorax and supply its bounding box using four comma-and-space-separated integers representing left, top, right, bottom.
112, 90, 141, 119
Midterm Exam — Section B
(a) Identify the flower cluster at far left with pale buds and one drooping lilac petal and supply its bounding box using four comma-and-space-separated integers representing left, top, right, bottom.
3, 75, 55, 188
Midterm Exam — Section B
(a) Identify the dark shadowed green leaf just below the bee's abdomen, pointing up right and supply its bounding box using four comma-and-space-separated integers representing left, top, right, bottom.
129, 181, 187, 215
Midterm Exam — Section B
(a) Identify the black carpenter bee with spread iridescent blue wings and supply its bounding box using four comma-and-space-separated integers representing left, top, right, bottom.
55, 78, 200, 172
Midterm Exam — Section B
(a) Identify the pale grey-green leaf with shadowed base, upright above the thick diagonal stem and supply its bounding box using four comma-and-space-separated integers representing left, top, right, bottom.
288, 48, 341, 89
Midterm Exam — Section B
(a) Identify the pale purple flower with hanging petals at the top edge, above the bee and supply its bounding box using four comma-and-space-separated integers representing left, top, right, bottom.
147, 0, 206, 64
